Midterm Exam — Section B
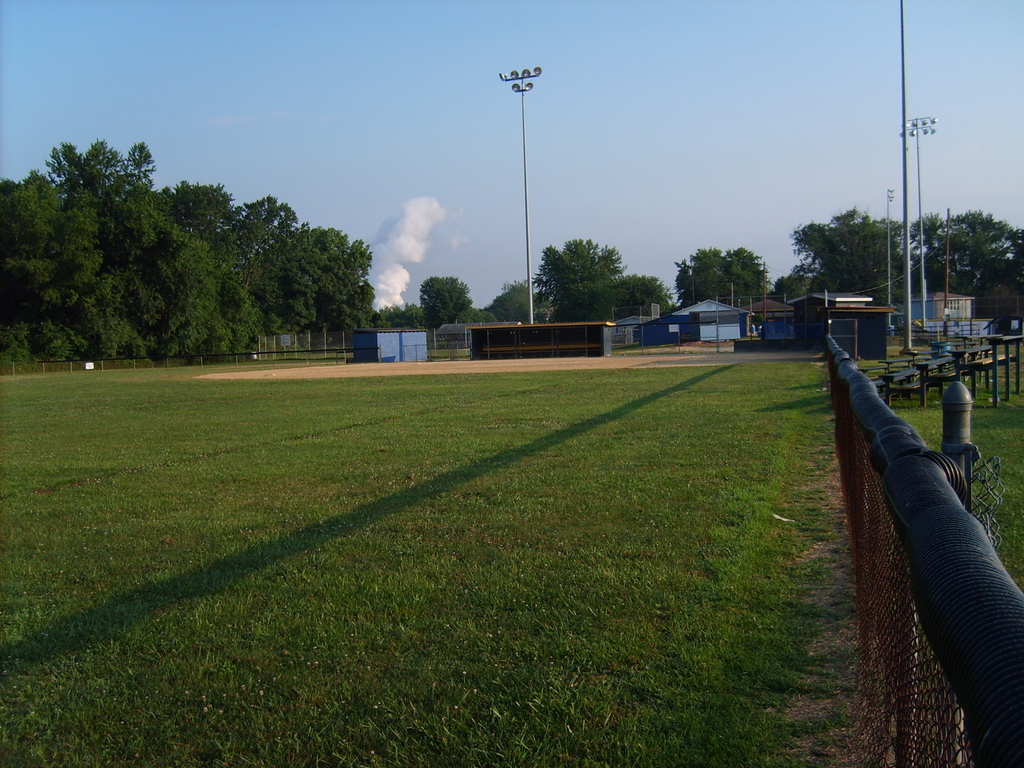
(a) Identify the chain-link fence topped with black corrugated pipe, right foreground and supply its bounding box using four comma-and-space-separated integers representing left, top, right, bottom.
827, 338, 1024, 768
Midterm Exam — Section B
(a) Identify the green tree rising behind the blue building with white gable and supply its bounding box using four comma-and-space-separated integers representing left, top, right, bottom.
676, 248, 764, 306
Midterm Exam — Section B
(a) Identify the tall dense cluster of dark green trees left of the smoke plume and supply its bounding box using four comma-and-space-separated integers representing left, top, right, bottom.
0, 141, 373, 358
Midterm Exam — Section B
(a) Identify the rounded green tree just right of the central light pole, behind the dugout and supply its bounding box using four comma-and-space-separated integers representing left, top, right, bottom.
537, 240, 623, 323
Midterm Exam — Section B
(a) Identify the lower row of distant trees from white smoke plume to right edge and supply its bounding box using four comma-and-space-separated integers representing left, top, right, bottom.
395, 208, 1024, 328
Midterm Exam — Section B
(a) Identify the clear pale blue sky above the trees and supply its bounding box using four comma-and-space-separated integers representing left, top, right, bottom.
0, 0, 1024, 306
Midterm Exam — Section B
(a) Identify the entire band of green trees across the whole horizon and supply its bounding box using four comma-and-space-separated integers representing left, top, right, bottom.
0, 141, 1024, 359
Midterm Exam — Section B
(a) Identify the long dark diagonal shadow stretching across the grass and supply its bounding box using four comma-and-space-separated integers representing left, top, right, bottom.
0, 366, 731, 675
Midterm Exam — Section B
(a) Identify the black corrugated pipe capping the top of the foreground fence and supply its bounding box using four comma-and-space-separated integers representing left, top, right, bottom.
827, 338, 1024, 768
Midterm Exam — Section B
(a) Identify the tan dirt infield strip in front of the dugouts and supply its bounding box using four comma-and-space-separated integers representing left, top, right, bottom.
199, 351, 821, 379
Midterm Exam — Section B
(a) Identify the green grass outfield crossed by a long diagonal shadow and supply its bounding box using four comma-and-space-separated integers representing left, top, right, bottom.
0, 362, 851, 766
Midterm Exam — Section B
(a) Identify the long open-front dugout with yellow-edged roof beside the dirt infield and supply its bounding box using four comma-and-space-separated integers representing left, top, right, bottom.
470, 323, 615, 360
